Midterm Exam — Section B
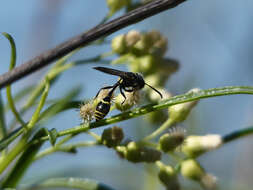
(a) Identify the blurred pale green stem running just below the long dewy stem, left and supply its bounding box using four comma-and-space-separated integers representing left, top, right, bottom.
34, 141, 99, 160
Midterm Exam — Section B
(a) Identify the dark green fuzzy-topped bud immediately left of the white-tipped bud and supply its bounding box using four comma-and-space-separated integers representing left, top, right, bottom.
159, 129, 185, 152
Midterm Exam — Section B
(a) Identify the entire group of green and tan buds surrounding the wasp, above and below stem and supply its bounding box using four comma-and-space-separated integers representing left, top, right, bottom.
80, 30, 219, 190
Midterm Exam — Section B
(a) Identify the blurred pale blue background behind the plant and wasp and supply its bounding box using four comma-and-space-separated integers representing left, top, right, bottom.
0, 0, 253, 190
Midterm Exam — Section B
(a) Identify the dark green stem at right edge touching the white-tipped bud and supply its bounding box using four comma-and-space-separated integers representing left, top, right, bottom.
222, 126, 253, 143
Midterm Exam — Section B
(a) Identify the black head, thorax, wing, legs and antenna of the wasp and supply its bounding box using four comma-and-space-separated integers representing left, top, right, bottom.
93, 67, 163, 104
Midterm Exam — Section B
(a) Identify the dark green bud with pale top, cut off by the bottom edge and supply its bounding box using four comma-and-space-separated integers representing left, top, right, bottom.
157, 162, 180, 190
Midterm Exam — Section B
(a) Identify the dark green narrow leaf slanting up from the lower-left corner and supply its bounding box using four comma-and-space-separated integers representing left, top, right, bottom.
2, 128, 47, 188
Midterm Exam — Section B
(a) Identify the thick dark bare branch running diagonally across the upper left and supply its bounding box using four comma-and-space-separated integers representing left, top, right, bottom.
0, 0, 186, 89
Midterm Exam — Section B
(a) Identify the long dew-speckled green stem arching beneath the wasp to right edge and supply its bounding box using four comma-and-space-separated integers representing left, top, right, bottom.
29, 86, 253, 143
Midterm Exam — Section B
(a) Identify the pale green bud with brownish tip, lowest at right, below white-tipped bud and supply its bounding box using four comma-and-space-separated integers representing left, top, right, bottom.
181, 159, 217, 190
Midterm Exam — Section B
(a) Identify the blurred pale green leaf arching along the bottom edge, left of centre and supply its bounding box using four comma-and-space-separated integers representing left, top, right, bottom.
28, 177, 114, 190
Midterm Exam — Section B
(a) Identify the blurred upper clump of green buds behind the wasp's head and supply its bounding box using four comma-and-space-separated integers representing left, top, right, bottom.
111, 30, 179, 122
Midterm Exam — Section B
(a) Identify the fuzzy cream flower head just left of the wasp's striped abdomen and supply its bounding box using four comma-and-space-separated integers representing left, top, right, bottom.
79, 101, 95, 122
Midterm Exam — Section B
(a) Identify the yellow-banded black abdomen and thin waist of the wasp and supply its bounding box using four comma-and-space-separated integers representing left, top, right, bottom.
94, 82, 117, 121
